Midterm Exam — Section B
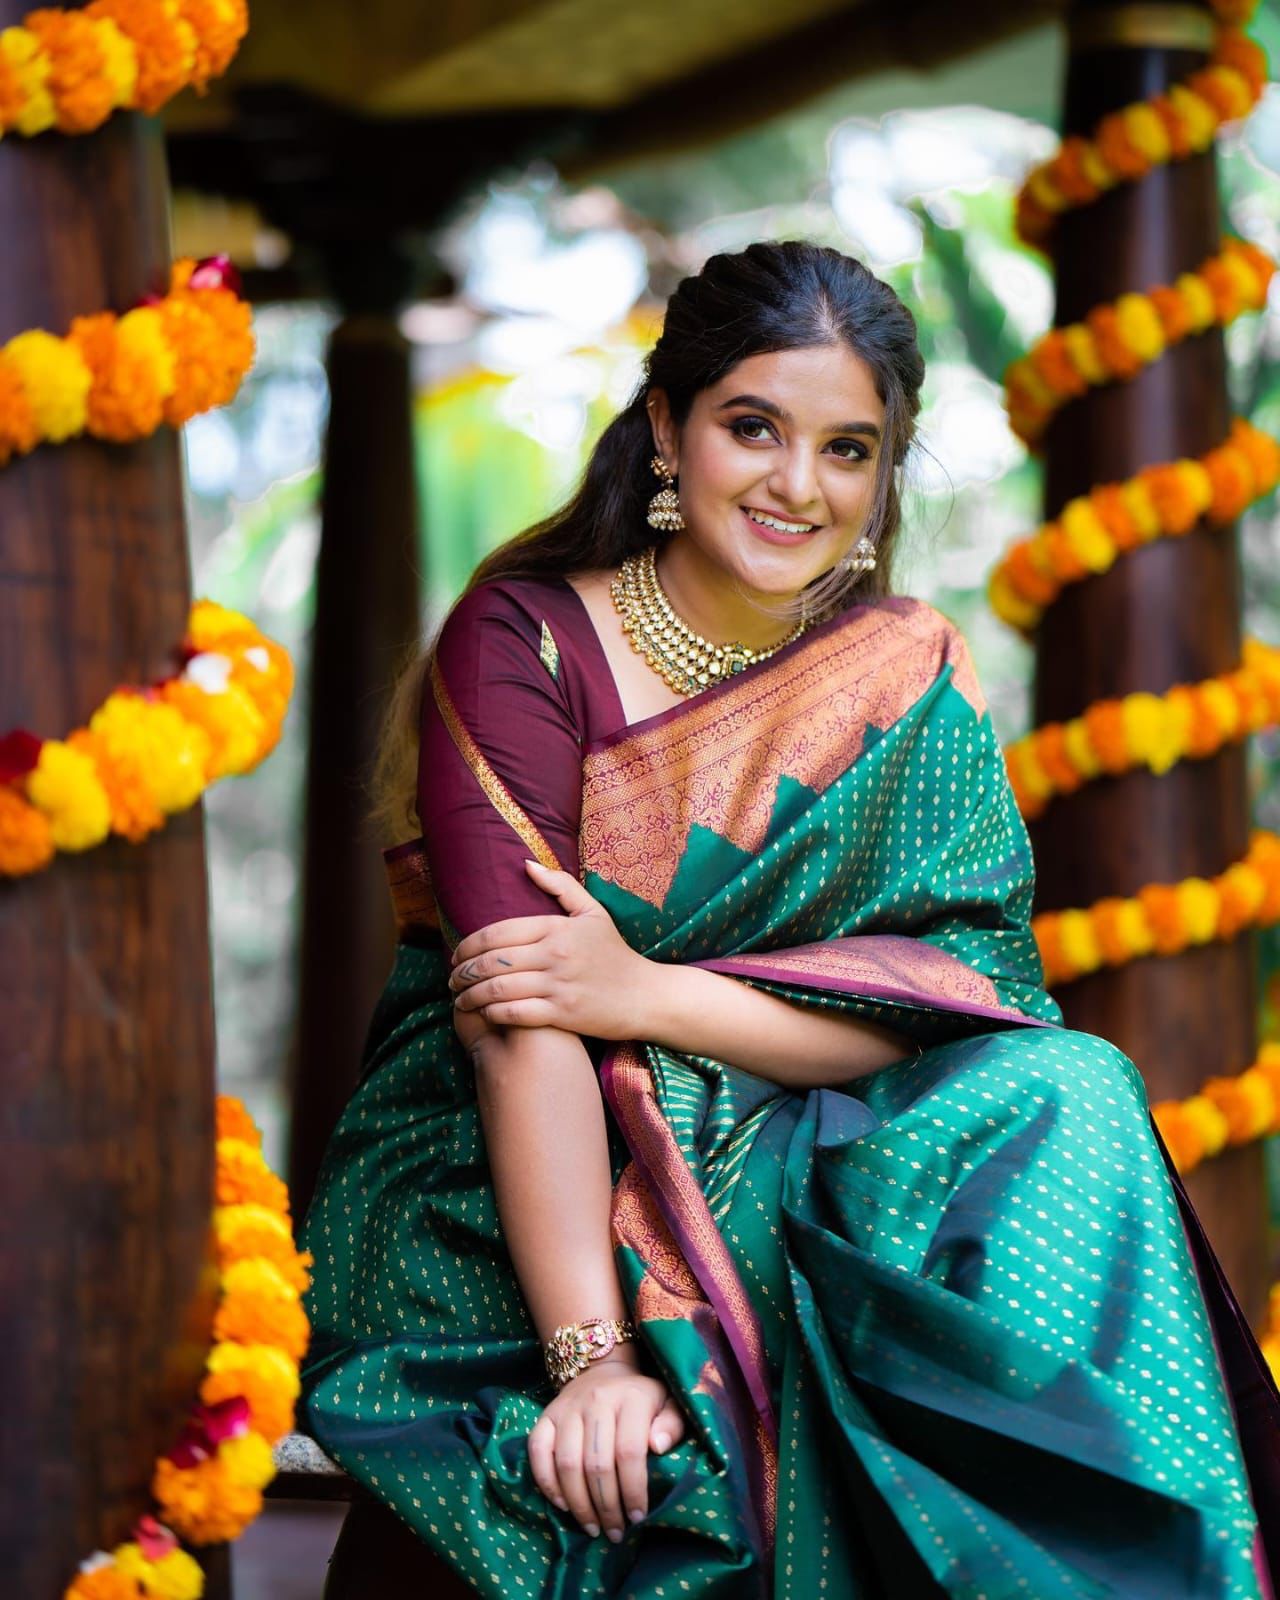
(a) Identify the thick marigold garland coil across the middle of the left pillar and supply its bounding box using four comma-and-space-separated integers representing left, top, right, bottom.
0, 600, 293, 876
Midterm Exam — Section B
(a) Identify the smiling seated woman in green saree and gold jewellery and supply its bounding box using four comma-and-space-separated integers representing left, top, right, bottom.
304, 243, 1280, 1600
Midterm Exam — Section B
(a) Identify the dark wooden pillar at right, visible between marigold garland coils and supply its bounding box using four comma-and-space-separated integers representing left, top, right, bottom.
1032, 0, 1266, 1320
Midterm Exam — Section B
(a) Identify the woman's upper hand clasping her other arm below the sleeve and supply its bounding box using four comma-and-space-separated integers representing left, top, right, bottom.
450, 861, 654, 1038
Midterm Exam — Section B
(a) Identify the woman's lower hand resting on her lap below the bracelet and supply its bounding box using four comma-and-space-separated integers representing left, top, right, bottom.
528, 1350, 685, 1544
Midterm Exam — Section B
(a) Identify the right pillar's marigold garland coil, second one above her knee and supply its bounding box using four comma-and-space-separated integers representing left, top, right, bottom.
1005, 638, 1280, 819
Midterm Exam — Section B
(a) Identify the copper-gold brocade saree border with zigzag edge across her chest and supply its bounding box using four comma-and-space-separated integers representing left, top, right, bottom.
579, 597, 986, 907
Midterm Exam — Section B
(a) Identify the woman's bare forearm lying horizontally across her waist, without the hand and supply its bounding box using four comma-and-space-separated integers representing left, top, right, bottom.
643, 962, 915, 1088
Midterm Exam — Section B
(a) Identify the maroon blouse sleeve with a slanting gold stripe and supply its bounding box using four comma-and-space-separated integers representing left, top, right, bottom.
418, 584, 582, 947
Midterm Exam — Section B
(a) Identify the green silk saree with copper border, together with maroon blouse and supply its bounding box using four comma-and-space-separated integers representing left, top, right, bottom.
302, 579, 1280, 1600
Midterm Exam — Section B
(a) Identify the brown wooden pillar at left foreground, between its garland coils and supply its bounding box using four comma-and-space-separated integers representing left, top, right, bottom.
0, 75, 214, 1600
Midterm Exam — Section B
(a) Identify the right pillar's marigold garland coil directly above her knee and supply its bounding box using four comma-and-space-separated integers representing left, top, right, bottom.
1030, 829, 1280, 986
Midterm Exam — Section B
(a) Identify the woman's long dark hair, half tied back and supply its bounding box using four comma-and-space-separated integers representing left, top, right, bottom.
373, 240, 925, 838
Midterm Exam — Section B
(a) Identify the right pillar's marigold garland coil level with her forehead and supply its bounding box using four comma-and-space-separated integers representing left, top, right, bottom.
1005, 238, 1275, 448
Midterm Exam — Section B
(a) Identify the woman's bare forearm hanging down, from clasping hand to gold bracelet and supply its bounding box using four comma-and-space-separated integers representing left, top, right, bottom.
472, 1027, 627, 1354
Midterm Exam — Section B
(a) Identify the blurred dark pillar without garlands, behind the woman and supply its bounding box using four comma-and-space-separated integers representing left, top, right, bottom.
290, 245, 419, 1216
